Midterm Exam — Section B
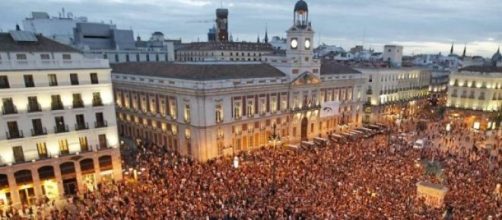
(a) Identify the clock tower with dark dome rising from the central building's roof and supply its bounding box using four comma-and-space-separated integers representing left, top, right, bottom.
286, 0, 320, 78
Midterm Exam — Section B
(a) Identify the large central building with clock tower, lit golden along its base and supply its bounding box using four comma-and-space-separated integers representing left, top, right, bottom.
112, 1, 365, 161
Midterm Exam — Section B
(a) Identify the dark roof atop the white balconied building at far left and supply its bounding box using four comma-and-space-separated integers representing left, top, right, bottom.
0, 33, 80, 53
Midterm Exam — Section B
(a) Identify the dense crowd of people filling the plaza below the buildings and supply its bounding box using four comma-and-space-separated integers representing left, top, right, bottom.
40, 116, 502, 219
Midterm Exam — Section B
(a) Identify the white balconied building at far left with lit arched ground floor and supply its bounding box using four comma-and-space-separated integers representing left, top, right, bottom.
0, 32, 122, 206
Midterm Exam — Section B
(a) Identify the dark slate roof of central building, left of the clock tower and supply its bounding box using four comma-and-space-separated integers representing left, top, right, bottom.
111, 62, 285, 81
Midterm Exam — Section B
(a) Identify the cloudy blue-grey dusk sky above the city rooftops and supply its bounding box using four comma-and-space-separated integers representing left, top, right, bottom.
0, 0, 502, 56
